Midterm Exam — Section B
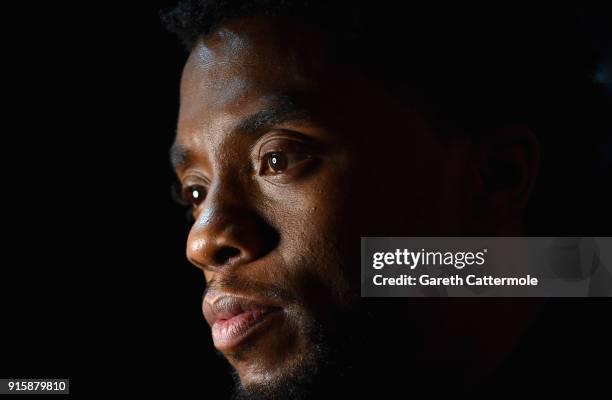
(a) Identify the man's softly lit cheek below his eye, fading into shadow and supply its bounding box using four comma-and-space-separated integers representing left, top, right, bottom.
260, 168, 360, 314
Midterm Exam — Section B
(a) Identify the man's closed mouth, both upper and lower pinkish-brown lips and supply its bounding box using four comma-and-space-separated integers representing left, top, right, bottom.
203, 292, 282, 351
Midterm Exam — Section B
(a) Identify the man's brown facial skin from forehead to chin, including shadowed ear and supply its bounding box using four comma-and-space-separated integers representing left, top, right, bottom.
173, 18, 537, 394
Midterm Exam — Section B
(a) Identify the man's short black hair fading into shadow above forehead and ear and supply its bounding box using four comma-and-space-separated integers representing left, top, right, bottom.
162, 0, 612, 235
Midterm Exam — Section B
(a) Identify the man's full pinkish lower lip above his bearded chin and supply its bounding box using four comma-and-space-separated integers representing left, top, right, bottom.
212, 308, 280, 350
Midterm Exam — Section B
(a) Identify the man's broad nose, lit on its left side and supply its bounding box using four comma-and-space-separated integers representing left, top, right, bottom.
187, 183, 278, 270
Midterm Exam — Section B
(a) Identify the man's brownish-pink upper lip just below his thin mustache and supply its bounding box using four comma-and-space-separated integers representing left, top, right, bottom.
203, 291, 280, 326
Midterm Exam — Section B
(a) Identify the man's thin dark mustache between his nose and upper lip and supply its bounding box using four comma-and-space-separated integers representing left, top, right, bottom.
202, 275, 296, 303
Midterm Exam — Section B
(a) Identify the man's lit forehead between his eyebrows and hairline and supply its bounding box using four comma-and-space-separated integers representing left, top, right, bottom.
181, 17, 334, 119
